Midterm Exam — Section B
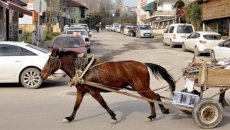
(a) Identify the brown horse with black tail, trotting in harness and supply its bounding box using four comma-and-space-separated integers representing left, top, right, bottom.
41, 49, 175, 123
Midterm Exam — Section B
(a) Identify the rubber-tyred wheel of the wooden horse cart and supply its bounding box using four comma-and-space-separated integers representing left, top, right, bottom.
192, 99, 223, 129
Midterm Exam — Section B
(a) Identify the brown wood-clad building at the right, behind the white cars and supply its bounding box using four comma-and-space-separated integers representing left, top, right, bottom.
200, 0, 230, 37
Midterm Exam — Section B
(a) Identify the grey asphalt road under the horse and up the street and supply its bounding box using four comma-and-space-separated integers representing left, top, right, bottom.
0, 31, 230, 130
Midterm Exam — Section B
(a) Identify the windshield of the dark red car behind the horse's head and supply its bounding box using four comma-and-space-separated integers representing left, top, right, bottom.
53, 37, 84, 48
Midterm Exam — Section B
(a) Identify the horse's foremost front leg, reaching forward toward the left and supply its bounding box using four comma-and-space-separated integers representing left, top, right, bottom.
62, 87, 86, 123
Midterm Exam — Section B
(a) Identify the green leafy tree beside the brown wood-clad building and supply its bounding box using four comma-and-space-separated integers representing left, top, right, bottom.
185, 2, 202, 30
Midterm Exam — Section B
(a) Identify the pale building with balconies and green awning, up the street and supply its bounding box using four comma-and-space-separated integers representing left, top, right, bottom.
137, 0, 191, 29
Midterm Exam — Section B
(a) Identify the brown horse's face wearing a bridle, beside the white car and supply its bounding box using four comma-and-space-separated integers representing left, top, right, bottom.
40, 49, 61, 79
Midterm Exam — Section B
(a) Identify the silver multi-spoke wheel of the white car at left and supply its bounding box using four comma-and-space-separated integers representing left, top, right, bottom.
20, 68, 43, 89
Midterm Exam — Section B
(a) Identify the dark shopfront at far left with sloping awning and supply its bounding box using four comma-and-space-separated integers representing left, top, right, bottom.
0, 0, 32, 41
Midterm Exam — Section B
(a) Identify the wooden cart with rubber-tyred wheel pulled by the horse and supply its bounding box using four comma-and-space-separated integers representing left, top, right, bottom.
181, 62, 230, 128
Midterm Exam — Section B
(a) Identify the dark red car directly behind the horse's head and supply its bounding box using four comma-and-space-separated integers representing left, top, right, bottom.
49, 34, 86, 54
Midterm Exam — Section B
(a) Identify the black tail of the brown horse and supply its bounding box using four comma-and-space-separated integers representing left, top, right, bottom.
145, 63, 175, 93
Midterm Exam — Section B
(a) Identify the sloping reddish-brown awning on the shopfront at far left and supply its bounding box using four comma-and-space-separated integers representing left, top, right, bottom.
7, 1, 32, 16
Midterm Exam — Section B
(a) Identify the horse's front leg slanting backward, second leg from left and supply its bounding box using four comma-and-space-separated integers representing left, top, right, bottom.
90, 90, 117, 124
